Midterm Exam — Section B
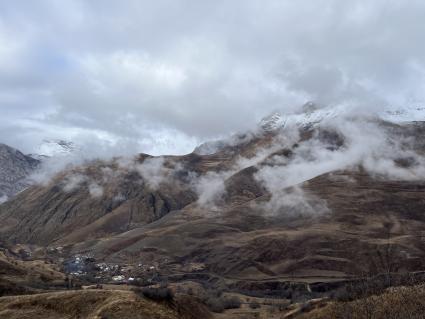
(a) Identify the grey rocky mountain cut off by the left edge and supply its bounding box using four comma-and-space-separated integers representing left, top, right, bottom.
0, 144, 40, 202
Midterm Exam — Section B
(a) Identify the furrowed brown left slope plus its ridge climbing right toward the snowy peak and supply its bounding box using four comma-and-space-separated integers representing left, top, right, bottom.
0, 129, 278, 244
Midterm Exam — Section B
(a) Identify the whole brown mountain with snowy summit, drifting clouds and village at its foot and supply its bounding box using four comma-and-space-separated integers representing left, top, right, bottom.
0, 109, 425, 318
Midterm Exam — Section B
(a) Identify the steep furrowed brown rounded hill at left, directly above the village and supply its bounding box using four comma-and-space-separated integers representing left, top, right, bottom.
0, 156, 197, 244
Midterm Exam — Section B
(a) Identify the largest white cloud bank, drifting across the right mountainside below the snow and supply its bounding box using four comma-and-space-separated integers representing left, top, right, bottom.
255, 116, 425, 212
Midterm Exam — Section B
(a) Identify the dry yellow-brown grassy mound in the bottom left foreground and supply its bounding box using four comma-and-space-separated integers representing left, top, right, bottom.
0, 290, 209, 319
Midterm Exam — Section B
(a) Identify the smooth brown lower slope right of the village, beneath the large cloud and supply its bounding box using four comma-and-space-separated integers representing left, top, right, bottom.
80, 172, 425, 281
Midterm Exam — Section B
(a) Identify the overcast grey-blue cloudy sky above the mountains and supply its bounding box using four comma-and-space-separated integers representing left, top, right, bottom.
0, 0, 425, 155
